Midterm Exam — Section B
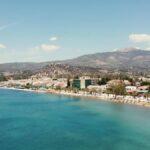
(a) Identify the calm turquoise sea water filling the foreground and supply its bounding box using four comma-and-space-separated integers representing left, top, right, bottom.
0, 90, 150, 150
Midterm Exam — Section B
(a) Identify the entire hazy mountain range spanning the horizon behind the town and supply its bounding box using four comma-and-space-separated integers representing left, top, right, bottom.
0, 48, 150, 73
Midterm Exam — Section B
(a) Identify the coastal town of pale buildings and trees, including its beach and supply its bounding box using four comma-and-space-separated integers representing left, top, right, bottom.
0, 73, 150, 106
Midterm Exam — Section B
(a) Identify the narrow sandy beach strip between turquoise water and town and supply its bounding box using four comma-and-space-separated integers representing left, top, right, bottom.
0, 87, 150, 108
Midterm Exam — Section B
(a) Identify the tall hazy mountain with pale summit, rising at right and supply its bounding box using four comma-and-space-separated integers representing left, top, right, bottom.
61, 48, 150, 71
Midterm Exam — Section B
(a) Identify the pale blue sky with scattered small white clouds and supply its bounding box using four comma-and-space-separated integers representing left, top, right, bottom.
0, 0, 150, 63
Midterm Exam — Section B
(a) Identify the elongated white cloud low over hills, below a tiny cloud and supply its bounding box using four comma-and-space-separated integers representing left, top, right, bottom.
31, 44, 60, 52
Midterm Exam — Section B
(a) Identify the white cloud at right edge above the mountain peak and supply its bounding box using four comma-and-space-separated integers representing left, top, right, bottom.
129, 34, 150, 43
